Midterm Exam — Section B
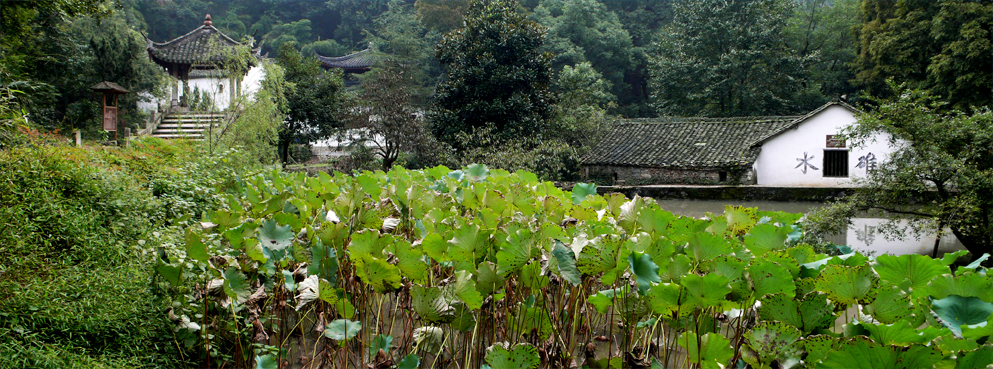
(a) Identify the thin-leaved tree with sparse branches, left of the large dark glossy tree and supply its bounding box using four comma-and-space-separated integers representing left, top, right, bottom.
355, 60, 432, 171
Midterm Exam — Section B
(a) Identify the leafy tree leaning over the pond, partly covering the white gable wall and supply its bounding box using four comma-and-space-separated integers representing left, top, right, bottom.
810, 87, 993, 257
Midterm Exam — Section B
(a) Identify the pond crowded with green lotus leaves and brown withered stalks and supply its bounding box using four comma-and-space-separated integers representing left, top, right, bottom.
155, 165, 993, 369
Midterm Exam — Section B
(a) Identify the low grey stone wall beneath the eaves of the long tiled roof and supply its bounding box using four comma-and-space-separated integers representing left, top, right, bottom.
583, 165, 753, 186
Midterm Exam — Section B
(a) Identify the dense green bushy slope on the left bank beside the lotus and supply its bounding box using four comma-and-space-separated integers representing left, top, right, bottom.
0, 139, 229, 368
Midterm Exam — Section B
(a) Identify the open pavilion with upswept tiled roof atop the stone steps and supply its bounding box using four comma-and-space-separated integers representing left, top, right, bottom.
147, 14, 261, 107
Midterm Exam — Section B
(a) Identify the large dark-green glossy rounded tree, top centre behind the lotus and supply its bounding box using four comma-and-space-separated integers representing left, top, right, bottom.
432, 0, 552, 149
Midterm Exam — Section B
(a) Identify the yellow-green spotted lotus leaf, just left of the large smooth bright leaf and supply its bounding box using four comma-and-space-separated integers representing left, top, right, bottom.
815, 265, 877, 305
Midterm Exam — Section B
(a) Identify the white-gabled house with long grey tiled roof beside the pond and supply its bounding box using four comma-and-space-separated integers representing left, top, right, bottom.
582, 102, 892, 187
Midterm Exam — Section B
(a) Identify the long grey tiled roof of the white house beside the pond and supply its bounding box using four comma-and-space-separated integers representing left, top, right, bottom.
582, 116, 802, 168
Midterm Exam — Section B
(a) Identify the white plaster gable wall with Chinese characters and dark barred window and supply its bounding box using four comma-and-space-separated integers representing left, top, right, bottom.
754, 105, 892, 187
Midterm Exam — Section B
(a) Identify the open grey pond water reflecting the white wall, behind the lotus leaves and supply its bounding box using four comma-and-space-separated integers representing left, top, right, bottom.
656, 199, 965, 255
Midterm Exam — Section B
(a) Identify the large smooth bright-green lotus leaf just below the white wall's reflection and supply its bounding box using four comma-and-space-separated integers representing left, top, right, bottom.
873, 254, 951, 298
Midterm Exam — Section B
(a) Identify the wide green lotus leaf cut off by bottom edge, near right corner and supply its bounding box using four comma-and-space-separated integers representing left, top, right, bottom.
816, 336, 943, 369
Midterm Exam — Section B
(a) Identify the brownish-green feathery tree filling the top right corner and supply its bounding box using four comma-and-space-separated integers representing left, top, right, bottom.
855, 1, 993, 111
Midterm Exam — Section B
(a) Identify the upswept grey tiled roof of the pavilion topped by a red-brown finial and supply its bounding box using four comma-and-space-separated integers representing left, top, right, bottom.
148, 15, 258, 69
